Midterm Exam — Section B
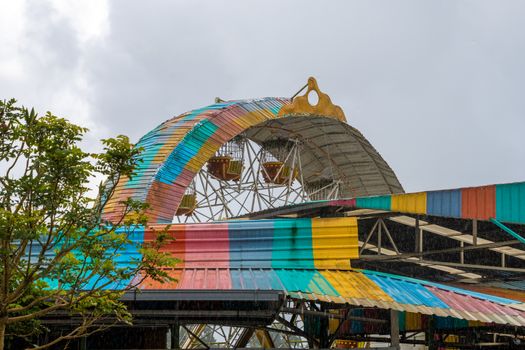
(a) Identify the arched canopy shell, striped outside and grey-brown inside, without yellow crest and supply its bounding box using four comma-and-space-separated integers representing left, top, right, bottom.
103, 97, 403, 223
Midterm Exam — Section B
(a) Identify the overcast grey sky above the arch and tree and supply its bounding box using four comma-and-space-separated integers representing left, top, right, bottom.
0, 0, 525, 191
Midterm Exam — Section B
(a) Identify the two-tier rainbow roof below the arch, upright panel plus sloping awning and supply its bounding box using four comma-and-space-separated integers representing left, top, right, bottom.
77, 218, 525, 326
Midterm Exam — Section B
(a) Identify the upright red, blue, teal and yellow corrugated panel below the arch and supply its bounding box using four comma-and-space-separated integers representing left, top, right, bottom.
144, 217, 359, 268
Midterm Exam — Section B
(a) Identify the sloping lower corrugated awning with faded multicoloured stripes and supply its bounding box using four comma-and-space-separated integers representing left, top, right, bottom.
136, 268, 525, 326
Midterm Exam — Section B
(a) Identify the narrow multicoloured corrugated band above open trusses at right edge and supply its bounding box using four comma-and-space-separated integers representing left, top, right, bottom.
355, 182, 525, 224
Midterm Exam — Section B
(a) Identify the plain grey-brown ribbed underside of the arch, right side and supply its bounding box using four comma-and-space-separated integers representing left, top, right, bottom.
245, 115, 403, 197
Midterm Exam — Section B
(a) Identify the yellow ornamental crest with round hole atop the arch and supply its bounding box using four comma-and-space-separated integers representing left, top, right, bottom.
277, 77, 346, 122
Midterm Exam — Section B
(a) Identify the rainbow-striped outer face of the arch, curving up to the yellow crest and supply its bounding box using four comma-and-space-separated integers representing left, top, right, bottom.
103, 98, 290, 223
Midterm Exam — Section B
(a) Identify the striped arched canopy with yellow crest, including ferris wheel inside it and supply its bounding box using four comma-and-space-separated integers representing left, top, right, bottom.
104, 78, 403, 223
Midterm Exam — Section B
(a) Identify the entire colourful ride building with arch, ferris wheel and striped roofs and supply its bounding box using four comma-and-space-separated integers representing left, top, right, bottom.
49, 78, 525, 349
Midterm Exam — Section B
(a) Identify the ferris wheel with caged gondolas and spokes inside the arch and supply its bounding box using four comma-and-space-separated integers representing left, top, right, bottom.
174, 133, 342, 222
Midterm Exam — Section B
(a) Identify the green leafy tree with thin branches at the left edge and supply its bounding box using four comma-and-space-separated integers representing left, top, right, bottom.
0, 100, 176, 350
